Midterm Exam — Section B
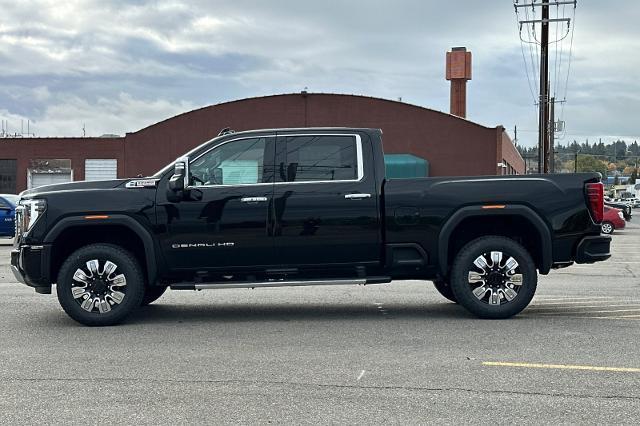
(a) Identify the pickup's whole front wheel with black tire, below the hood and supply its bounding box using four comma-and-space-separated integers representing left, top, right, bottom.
56, 244, 144, 326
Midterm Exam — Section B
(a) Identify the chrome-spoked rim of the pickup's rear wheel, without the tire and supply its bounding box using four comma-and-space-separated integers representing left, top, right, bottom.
467, 251, 523, 306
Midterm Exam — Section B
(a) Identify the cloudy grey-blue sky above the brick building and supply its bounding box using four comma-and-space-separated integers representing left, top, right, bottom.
0, 0, 640, 145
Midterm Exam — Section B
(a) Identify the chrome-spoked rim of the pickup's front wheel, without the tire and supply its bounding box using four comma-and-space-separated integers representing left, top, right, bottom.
71, 259, 127, 314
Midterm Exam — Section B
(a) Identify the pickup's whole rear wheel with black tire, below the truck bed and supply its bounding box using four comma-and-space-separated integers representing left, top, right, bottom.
451, 236, 538, 319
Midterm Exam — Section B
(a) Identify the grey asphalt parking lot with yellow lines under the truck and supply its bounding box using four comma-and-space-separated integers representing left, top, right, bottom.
0, 225, 640, 424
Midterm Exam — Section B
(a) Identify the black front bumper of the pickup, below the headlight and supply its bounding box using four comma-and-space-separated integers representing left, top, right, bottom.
11, 244, 51, 293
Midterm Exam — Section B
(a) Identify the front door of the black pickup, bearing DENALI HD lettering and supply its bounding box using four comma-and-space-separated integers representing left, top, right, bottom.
157, 135, 275, 270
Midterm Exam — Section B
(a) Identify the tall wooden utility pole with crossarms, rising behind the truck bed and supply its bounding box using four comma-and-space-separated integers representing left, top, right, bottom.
514, 0, 577, 173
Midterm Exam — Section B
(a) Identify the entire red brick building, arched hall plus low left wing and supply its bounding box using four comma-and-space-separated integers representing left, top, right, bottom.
0, 92, 525, 192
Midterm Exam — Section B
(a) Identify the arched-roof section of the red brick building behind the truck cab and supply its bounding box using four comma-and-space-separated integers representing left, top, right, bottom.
125, 92, 522, 175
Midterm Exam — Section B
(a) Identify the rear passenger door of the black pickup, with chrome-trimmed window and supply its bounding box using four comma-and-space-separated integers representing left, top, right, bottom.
274, 133, 381, 267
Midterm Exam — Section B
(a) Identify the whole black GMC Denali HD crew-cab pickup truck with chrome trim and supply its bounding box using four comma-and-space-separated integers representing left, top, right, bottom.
11, 128, 611, 325
